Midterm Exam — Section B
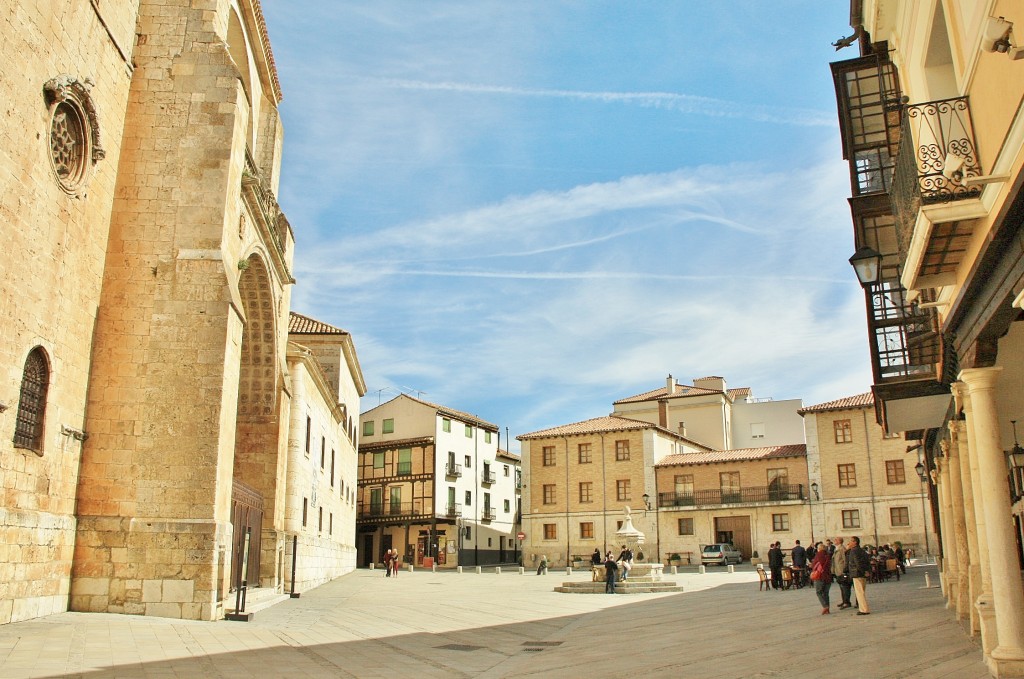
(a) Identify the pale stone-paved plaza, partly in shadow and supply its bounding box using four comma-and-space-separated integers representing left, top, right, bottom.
0, 564, 989, 679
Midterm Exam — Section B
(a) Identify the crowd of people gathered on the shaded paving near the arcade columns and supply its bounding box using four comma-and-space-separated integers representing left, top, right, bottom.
768, 536, 876, 616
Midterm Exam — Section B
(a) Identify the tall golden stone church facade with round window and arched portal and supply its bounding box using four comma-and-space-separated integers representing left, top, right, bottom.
0, 0, 357, 622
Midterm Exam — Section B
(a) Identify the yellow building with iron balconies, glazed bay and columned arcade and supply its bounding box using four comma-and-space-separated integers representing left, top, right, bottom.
831, 0, 1024, 676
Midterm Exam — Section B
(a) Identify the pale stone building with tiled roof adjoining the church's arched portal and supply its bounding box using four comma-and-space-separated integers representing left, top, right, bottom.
279, 312, 367, 591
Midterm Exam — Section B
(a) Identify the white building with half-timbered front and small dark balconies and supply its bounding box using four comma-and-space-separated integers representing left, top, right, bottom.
356, 394, 519, 567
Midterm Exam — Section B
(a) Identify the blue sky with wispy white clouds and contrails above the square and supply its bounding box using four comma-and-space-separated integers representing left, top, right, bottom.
263, 0, 870, 450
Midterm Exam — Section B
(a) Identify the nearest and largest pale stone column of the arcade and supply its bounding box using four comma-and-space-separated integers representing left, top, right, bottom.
959, 368, 1024, 677
